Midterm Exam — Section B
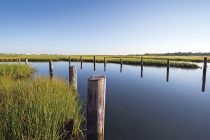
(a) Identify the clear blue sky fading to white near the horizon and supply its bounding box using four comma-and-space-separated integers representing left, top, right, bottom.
0, 0, 210, 54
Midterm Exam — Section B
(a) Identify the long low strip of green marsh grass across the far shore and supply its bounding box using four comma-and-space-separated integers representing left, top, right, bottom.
0, 55, 203, 69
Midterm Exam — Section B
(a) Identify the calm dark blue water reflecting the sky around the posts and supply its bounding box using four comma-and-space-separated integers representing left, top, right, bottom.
30, 62, 210, 140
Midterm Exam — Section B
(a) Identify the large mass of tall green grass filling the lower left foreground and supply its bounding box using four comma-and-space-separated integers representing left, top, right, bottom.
0, 77, 84, 140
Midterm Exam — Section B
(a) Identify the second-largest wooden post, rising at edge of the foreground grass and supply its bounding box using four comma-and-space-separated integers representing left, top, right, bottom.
69, 66, 77, 90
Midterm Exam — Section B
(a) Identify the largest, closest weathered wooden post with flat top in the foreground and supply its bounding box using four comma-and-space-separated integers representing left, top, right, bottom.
87, 76, 106, 140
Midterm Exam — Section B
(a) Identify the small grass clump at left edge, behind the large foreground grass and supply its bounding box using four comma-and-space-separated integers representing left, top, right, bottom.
0, 64, 36, 79
